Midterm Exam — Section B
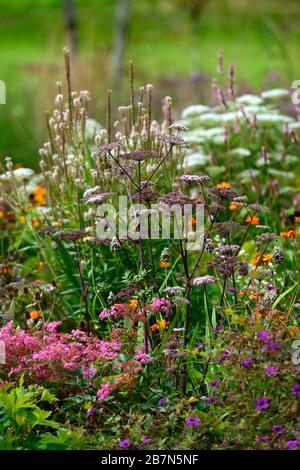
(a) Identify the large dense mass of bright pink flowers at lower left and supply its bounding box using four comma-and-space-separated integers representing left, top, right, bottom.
0, 322, 120, 381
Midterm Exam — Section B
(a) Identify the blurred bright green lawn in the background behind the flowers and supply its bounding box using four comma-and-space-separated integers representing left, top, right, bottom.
0, 0, 300, 165
